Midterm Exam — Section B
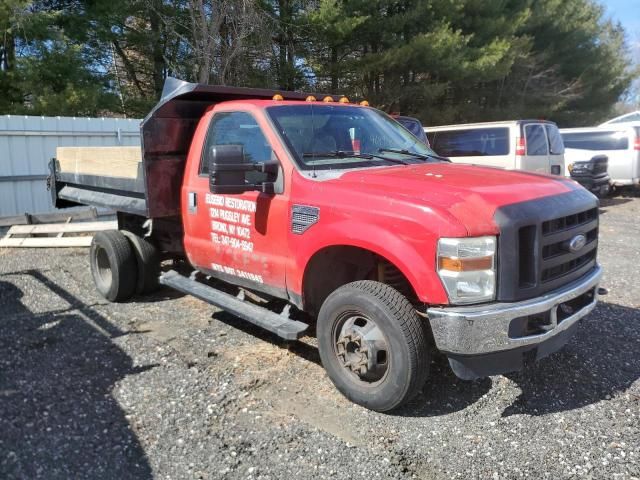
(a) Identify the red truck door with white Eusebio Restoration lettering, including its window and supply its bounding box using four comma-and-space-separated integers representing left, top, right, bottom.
183, 111, 289, 296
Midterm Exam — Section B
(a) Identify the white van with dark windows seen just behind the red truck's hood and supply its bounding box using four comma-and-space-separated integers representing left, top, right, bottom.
424, 120, 565, 175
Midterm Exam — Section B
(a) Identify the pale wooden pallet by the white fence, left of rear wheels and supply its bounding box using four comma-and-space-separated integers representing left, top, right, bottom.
0, 218, 118, 248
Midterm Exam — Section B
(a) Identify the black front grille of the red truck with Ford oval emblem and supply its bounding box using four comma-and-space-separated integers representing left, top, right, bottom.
495, 189, 598, 301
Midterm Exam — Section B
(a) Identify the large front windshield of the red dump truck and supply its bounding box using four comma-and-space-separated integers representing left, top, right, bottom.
267, 104, 437, 170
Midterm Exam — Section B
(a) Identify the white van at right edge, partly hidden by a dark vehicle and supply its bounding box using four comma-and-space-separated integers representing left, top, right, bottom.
560, 124, 640, 187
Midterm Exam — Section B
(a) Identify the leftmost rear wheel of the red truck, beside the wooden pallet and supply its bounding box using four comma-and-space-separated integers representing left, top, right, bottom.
89, 230, 138, 302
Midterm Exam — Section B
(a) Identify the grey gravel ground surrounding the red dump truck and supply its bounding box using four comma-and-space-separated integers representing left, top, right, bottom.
0, 198, 640, 479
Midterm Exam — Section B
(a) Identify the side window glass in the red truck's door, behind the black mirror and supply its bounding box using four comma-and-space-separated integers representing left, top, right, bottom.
200, 112, 272, 182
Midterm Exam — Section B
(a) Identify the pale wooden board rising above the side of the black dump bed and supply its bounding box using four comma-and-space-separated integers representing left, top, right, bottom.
56, 147, 142, 178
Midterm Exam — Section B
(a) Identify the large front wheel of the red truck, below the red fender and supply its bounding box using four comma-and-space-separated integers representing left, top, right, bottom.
317, 280, 430, 412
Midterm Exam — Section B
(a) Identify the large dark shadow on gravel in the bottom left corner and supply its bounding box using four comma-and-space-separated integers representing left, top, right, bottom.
0, 271, 152, 479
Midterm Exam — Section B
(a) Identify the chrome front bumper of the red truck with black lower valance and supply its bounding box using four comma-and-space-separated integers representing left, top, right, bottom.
427, 265, 602, 378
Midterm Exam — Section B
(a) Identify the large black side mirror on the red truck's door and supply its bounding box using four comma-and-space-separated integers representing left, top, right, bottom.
209, 145, 280, 194
